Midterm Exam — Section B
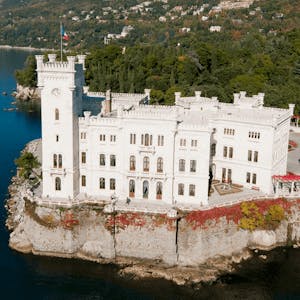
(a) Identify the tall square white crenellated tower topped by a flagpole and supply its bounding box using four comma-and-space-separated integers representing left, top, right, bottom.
36, 54, 85, 200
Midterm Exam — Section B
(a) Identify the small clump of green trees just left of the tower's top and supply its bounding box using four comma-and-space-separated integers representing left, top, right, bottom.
15, 55, 37, 87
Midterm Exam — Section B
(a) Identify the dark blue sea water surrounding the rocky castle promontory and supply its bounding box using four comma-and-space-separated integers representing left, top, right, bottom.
0, 49, 300, 300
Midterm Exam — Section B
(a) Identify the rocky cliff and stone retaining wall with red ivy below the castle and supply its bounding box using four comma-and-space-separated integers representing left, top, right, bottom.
7, 140, 300, 284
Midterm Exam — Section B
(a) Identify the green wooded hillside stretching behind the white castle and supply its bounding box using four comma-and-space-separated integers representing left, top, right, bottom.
11, 0, 300, 114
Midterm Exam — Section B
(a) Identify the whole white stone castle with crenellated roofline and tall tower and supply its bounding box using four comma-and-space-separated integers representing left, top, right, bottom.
36, 54, 294, 206
